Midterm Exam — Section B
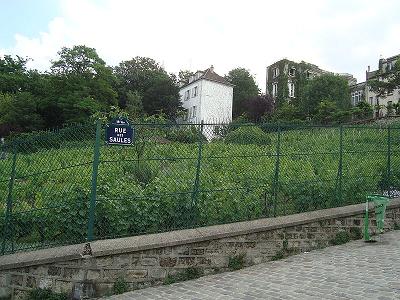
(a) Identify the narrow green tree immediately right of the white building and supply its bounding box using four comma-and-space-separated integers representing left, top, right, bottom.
225, 68, 260, 118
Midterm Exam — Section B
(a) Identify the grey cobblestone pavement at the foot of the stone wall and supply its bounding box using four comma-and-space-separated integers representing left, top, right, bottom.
107, 231, 400, 300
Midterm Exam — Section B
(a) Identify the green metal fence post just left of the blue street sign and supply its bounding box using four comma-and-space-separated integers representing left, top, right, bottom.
87, 120, 101, 242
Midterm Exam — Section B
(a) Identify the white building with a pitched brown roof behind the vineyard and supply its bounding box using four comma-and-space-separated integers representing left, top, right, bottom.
179, 66, 233, 123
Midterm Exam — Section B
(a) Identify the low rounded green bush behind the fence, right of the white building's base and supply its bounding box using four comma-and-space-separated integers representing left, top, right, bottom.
225, 125, 271, 145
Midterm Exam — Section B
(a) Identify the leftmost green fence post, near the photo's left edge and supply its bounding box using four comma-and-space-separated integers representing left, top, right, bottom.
1, 145, 17, 254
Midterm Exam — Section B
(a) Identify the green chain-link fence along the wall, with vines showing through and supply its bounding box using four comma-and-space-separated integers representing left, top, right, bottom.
0, 123, 400, 254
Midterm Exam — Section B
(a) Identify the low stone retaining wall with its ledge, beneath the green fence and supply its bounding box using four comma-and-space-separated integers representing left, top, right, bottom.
0, 199, 400, 299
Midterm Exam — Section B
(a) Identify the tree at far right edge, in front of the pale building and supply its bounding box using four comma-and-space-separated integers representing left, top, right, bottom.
369, 59, 400, 96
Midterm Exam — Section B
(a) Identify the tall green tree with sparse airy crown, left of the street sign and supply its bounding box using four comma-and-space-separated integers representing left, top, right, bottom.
48, 45, 117, 126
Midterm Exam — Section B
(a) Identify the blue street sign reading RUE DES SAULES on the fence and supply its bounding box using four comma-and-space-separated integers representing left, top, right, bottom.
106, 118, 134, 146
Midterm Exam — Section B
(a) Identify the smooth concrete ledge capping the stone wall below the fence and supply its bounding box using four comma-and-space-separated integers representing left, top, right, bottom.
0, 198, 400, 270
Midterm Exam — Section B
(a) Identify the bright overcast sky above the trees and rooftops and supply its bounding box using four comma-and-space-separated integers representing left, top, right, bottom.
0, 0, 400, 91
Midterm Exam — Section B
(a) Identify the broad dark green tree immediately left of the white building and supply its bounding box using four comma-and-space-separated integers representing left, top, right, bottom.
114, 57, 181, 118
